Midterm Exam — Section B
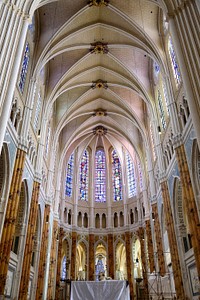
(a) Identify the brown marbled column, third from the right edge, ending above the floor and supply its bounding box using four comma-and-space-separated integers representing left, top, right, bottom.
152, 203, 166, 276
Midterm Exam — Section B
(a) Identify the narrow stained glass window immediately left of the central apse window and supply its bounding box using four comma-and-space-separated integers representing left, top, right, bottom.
79, 150, 89, 201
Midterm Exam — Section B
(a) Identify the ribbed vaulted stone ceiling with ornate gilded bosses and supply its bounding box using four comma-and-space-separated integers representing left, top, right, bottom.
32, 0, 167, 164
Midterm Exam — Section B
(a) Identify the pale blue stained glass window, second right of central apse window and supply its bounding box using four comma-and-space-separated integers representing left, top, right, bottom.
126, 152, 136, 197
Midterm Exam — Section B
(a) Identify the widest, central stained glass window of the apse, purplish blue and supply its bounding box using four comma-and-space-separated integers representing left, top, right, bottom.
95, 150, 106, 202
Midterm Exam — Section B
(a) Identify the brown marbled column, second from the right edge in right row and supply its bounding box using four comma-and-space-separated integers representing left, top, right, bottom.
161, 181, 186, 300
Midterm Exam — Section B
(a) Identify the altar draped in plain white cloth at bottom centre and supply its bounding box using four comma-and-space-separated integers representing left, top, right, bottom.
70, 280, 130, 300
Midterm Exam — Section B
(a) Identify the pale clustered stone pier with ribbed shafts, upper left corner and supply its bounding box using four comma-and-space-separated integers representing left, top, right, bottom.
0, 5, 29, 152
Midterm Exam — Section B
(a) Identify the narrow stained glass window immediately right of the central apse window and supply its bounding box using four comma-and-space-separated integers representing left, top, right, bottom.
112, 150, 122, 201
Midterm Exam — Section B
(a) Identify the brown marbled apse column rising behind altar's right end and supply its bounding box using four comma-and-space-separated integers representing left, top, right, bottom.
125, 231, 134, 300
